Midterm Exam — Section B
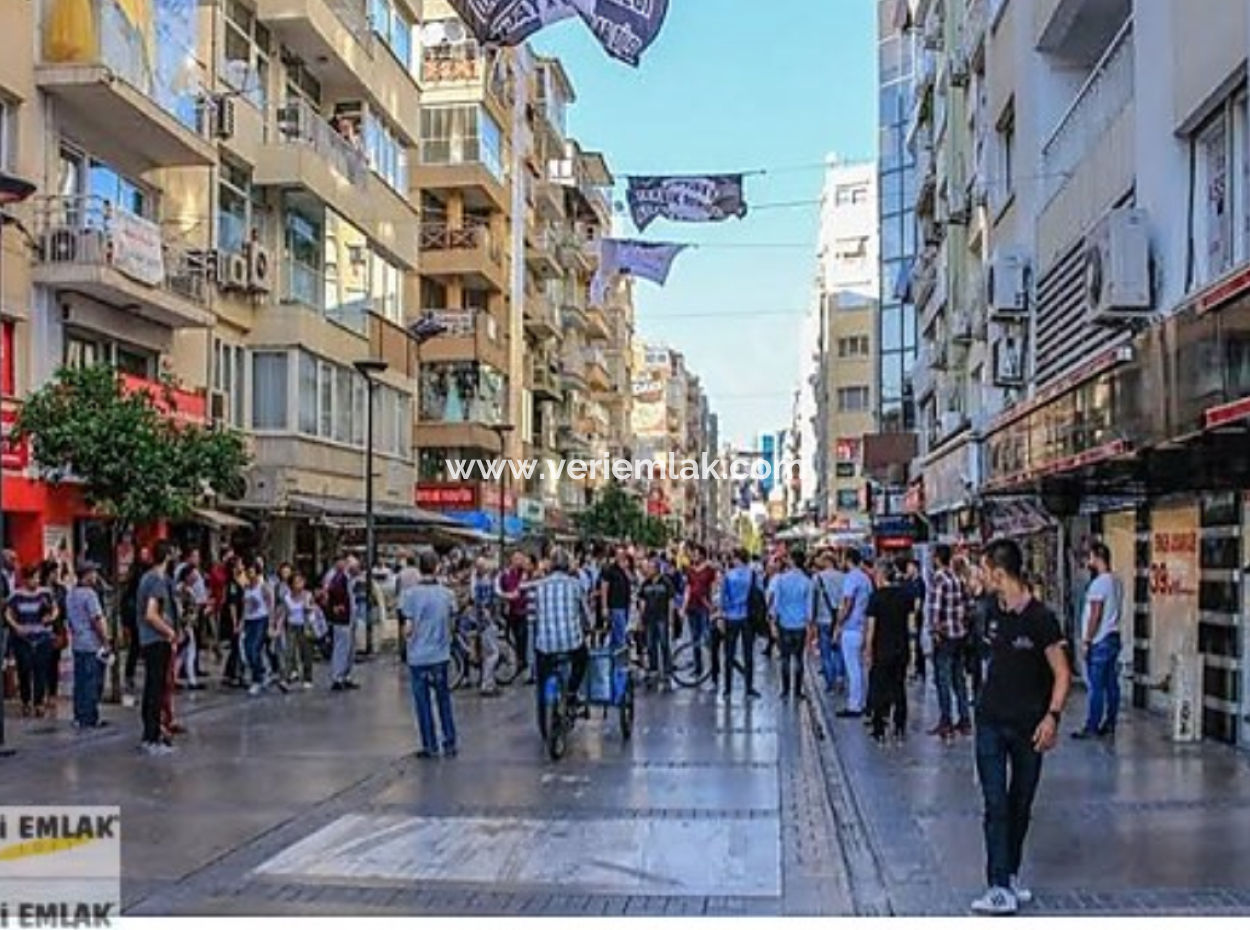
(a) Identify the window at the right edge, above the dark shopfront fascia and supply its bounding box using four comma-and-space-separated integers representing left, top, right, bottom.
1190, 94, 1250, 285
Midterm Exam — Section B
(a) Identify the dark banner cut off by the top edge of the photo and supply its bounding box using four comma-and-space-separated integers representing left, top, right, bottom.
449, 0, 669, 68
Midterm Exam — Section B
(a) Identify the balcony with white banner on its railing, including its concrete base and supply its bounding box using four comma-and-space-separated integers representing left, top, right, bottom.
34, 196, 214, 329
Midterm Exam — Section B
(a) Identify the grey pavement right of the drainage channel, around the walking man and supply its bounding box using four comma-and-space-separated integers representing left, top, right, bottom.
821, 685, 1250, 915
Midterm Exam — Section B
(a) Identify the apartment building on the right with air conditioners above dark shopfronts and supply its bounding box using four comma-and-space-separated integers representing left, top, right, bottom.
910, 0, 1250, 744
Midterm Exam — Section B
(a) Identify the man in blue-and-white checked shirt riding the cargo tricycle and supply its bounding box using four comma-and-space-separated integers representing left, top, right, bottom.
529, 549, 591, 725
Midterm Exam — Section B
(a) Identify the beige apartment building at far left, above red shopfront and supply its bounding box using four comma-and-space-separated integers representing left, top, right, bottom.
0, 0, 420, 561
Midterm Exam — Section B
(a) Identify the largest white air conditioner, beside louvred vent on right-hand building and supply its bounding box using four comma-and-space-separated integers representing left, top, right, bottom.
1085, 208, 1154, 326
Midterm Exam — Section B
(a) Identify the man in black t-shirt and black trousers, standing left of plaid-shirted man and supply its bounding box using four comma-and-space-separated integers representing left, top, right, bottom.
864, 561, 914, 743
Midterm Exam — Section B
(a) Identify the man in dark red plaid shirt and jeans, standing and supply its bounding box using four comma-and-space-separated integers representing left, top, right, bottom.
925, 545, 973, 739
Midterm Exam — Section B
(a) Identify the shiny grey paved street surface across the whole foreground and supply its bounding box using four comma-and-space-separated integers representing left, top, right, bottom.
0, 655, 1250, 916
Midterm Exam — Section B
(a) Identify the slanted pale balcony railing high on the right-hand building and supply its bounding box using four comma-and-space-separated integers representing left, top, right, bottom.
1041, 20, 1134, 204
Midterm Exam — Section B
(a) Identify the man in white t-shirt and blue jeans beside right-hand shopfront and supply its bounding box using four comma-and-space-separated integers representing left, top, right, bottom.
1073, 543, 1124, 740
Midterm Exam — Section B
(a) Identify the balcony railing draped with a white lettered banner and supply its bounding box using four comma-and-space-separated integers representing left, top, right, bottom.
35, 195, 209, 305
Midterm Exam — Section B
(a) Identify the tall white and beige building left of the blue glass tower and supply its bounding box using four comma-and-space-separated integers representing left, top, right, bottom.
794, 163, 885, 526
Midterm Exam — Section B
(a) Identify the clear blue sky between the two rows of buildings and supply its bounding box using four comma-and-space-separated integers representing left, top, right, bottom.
535, 0, 876, 443
